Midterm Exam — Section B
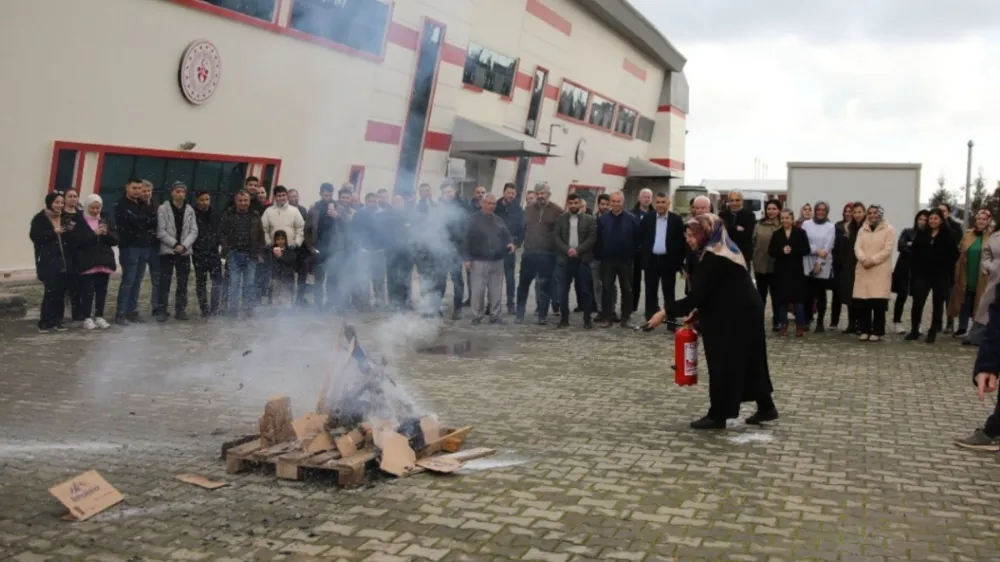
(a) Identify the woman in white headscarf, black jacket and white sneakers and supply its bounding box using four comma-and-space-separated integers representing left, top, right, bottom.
74, 194, 118, 330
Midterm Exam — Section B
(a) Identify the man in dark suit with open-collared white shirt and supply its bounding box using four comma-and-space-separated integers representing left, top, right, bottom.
639, 193, 687, 320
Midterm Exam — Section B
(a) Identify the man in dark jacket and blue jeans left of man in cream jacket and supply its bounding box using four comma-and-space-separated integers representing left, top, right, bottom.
219, 191, 266, 318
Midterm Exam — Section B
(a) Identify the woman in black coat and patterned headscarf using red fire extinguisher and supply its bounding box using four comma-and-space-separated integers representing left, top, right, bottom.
638, 213, 778, 429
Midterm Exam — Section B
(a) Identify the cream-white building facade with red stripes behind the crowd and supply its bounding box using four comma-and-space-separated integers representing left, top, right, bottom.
0, 0, 688, 272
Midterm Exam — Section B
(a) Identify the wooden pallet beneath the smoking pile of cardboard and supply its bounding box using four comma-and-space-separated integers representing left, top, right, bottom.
225, 439, 375, 488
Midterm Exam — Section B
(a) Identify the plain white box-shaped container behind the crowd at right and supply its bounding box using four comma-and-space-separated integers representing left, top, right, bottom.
786, 162, 921, 263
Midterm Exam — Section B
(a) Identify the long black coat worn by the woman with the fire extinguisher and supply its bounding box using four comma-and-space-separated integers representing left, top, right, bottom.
667, 252, 774, 419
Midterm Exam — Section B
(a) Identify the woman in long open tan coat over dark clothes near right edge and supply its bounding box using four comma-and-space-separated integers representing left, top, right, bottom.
948, 209, 993, 338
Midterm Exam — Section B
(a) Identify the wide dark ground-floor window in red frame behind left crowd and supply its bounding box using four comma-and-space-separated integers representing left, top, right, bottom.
98, 153, 250, 224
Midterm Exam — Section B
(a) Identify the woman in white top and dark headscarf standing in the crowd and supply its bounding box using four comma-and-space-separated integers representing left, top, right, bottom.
802, 201, 837, 333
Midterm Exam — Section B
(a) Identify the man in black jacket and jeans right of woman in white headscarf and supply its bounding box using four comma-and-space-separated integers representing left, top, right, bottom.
115, 178, 159, 326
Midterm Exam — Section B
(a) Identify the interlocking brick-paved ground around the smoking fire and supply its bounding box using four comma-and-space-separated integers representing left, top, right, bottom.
0, 278, 1000, 562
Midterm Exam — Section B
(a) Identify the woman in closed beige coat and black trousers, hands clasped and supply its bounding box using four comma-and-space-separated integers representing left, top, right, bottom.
853, 205, 896, 341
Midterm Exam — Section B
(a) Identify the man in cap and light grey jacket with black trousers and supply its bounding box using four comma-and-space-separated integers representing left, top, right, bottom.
153, 182, 198, 322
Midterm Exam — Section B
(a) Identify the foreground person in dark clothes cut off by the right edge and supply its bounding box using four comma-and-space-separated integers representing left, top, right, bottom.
955, 285, 1000, 452
